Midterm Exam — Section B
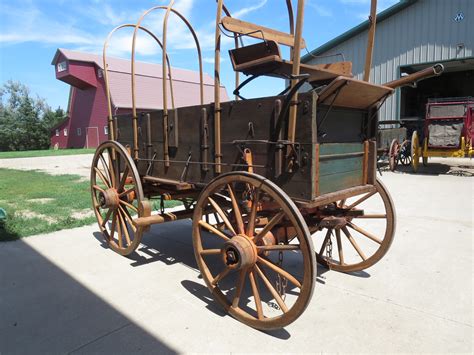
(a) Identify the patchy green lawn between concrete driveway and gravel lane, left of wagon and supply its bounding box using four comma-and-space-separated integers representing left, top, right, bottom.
0, 169, 181, 242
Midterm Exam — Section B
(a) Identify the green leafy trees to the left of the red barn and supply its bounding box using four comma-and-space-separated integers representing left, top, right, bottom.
0, 81, 64, 150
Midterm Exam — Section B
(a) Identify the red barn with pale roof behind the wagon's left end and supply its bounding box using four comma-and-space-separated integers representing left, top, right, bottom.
51, 49, 227, 148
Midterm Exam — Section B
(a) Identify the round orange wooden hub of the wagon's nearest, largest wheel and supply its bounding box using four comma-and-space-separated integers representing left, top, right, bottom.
221, 235, 257, 270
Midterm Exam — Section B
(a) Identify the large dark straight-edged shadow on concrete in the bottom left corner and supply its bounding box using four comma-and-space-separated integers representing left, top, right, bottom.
0, 240, 176, 354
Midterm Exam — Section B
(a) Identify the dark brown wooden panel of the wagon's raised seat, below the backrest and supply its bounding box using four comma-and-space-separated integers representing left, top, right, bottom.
229, 41, 281, 70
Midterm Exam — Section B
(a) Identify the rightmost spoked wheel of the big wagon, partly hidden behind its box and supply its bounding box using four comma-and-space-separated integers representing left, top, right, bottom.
315, 180, 395, 272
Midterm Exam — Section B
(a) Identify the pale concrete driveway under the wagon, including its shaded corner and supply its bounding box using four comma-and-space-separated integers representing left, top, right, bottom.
0, 160, 474, 355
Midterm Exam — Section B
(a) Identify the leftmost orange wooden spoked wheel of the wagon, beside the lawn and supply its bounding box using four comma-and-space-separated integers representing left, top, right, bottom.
91, 141, 143, 255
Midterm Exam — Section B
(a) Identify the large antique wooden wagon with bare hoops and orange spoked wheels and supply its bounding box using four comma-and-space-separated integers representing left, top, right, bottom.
91, 0, 436, 329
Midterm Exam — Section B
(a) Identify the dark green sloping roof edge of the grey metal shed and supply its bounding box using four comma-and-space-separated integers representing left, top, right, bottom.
301, 0, 418, 62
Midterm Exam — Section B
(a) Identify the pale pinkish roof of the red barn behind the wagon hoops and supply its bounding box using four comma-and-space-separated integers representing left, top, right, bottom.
51, 48, 228, 109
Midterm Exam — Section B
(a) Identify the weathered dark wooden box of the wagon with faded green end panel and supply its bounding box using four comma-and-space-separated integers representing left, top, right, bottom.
115, 93, 376, 202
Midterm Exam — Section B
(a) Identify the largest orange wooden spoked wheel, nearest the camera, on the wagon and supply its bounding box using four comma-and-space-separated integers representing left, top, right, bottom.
193, 172, 316, 330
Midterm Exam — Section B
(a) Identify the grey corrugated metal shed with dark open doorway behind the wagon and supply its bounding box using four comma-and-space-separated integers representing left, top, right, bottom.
302, 0, 474, 120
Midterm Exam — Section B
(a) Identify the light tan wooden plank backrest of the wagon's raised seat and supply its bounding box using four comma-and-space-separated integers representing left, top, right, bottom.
221, 16, 306, 48
